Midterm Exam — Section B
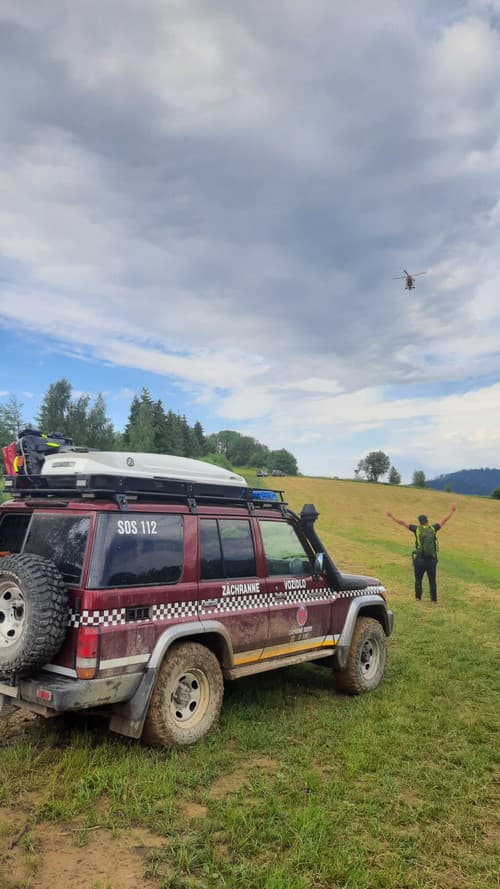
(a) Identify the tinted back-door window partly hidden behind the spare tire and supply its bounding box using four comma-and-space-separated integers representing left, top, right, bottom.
22, 514, 90, 584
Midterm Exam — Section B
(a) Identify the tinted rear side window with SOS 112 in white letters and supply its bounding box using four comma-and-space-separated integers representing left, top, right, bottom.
88, 513, 184, 589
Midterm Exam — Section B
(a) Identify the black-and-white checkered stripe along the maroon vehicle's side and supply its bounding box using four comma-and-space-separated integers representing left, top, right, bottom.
68, 586, 384, 628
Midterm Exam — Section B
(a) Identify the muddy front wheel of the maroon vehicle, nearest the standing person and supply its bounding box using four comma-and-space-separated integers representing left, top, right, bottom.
333, 617, 387, 695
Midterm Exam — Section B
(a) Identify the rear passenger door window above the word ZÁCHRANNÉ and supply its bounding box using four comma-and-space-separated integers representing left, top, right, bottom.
200, 519, 257, 580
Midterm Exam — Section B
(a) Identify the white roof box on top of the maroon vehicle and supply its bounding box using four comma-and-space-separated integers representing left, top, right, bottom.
41, 451, 248, 488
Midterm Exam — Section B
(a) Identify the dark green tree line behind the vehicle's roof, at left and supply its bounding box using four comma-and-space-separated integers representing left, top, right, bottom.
0, 379, 298, 475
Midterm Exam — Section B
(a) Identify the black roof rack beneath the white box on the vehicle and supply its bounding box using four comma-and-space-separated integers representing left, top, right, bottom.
4, 473, 287, 512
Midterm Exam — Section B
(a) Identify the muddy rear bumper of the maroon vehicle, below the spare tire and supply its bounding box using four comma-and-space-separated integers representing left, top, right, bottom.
0, 673, 143, 716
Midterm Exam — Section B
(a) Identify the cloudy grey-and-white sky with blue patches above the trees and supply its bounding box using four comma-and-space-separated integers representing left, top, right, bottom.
0, 0, 500, 481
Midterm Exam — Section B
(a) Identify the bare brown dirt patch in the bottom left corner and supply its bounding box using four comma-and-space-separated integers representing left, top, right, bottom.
0, 810, 164, 889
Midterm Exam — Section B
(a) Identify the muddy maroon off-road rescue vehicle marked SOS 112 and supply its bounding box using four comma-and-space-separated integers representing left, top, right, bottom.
0, 446, 393, 747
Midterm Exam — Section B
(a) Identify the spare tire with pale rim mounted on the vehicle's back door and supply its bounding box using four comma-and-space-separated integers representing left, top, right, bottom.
0, 553, 69, 675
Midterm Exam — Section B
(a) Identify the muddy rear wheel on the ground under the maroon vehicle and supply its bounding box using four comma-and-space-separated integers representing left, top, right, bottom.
142, 642, 224, 747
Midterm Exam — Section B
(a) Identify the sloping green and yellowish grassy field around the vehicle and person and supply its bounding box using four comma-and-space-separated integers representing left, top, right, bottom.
0, 478, 500, 889
